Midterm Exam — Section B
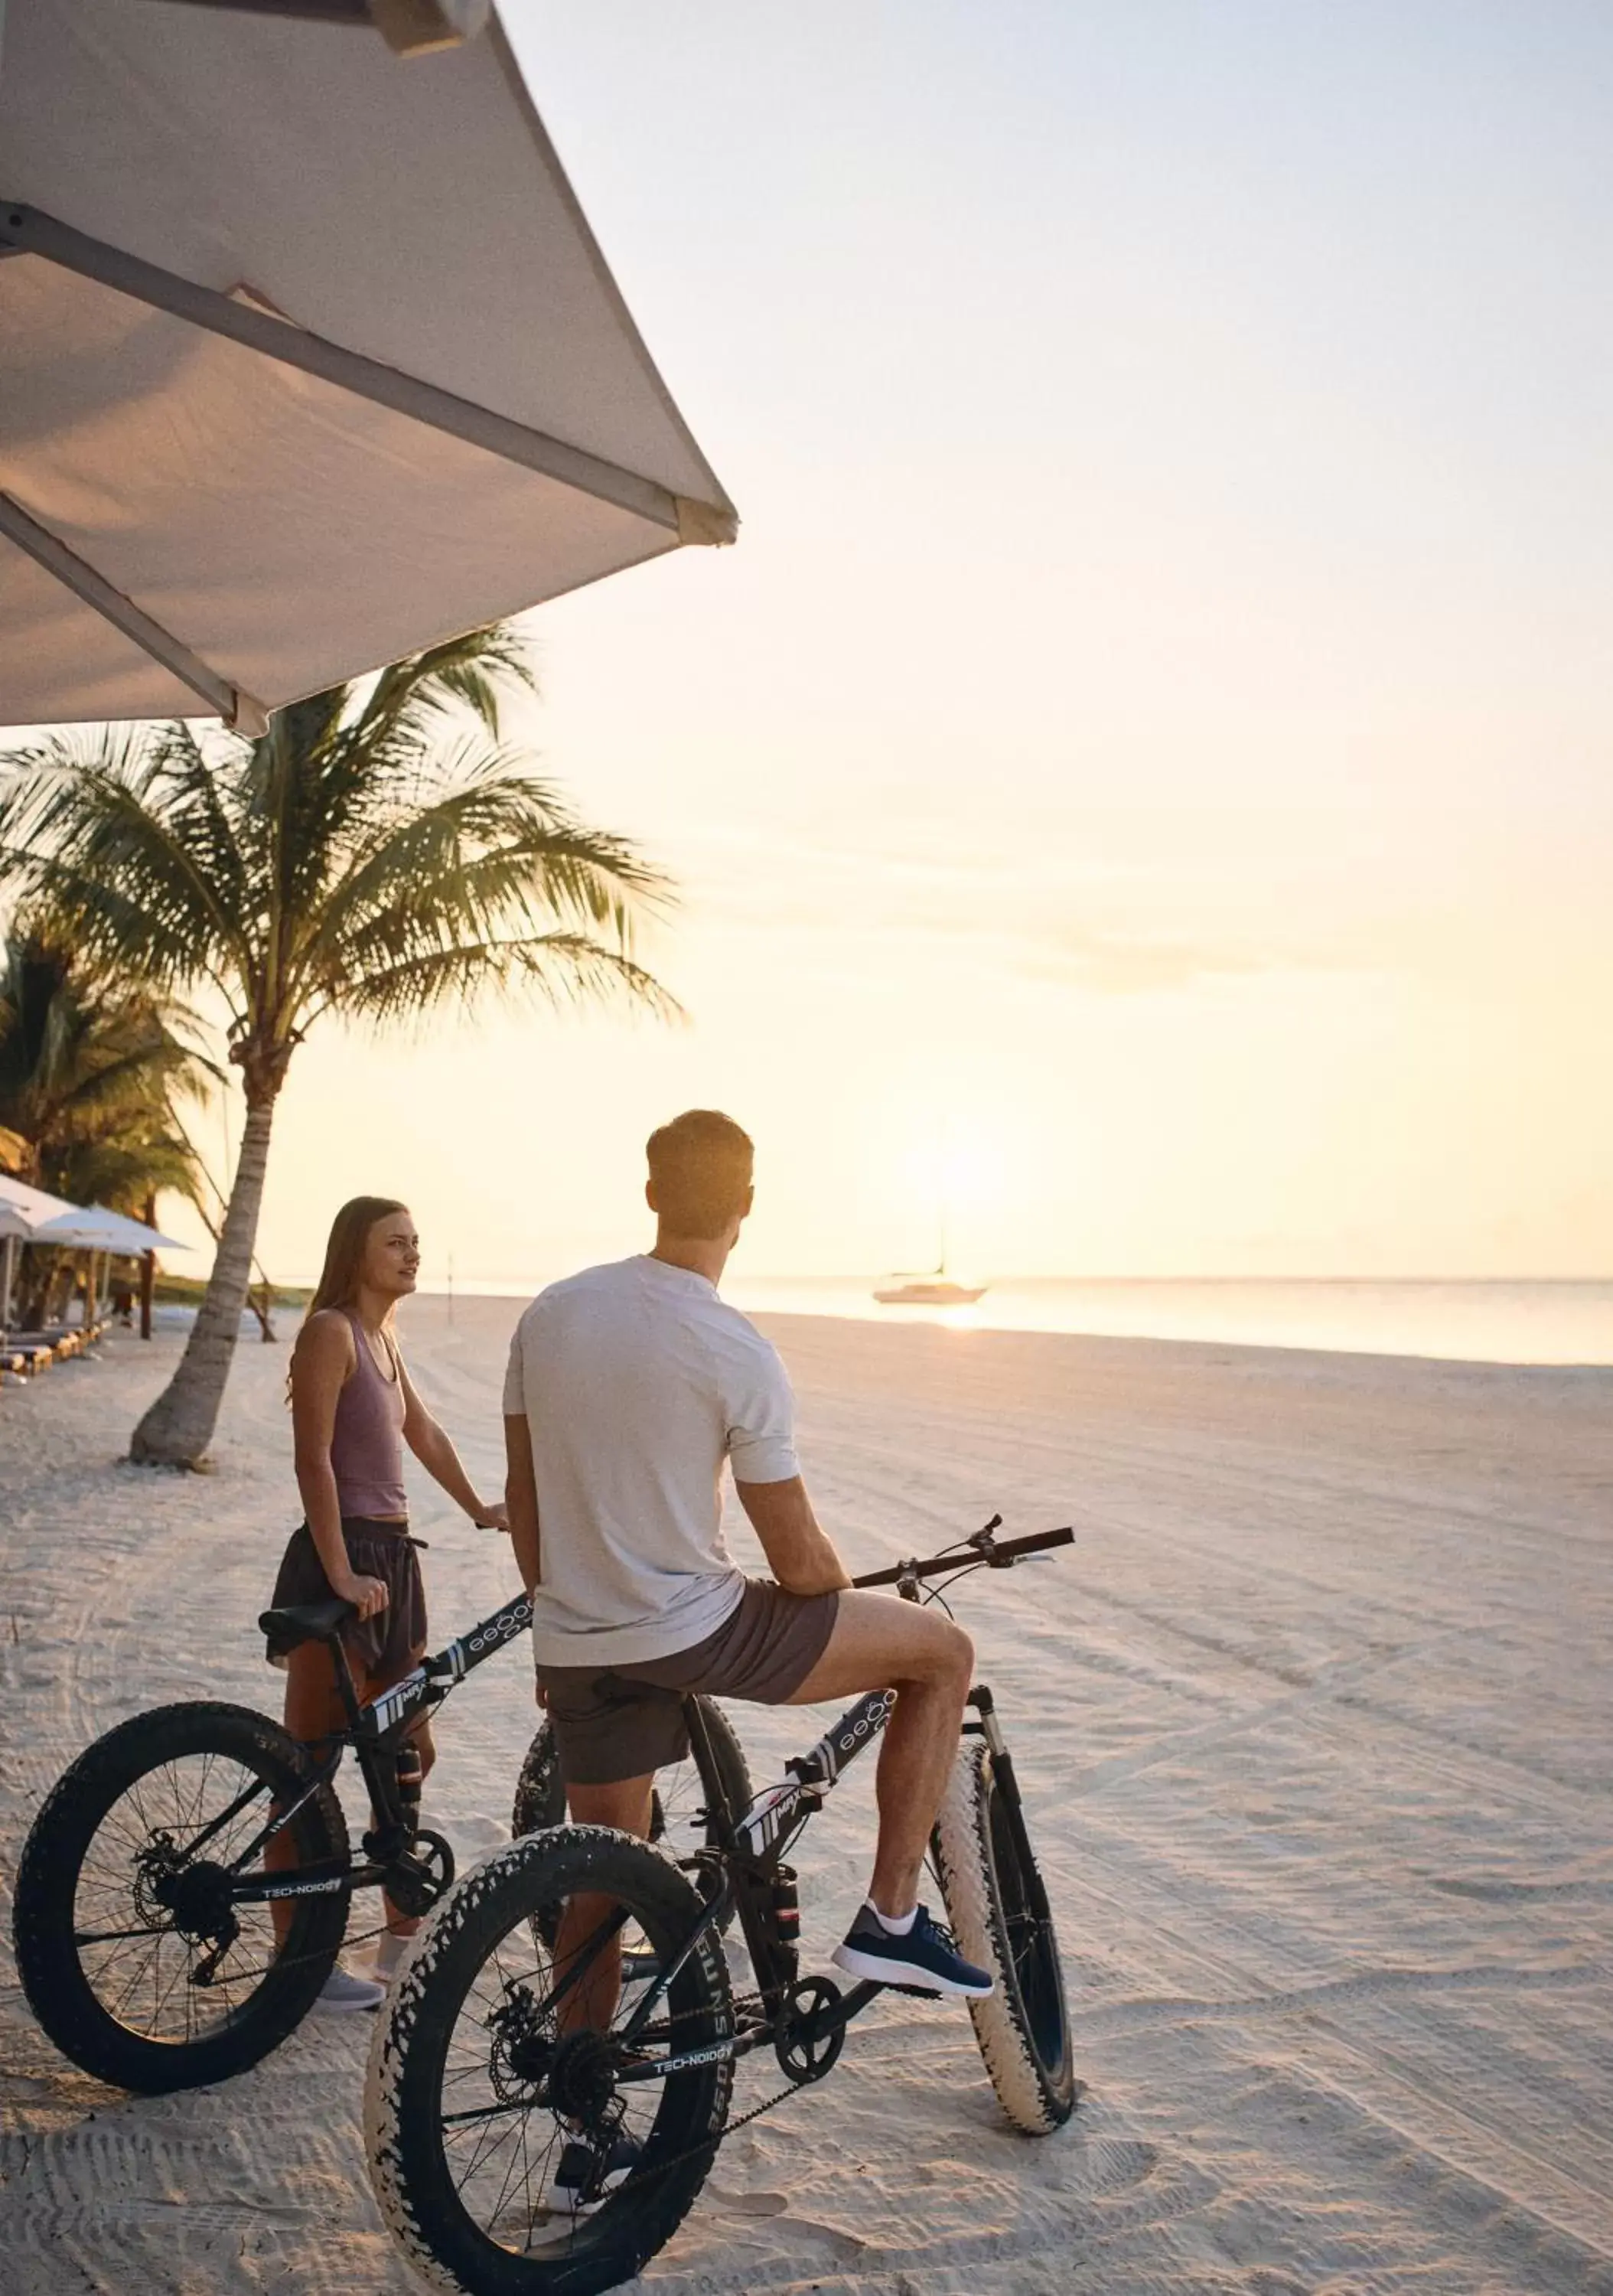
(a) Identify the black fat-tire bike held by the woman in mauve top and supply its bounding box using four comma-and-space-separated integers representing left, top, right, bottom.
11, 1596, 729, 2094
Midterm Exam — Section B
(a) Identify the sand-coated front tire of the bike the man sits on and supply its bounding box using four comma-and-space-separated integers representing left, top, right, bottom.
936, 1738, 1078, 2138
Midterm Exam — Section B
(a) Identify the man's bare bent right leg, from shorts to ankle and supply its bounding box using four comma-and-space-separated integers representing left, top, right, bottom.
790, 1591, 975, 1919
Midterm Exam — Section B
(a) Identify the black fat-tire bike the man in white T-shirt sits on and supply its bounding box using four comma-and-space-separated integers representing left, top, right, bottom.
365, 1518, 1078, 2296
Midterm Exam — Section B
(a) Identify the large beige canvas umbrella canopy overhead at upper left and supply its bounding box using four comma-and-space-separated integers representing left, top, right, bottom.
0, 0, 735, 730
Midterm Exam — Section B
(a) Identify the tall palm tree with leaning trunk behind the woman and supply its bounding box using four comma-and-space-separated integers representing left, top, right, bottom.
0, 629, 673, 1467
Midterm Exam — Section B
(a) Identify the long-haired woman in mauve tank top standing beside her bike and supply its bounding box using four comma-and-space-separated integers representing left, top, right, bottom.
269, 1196, 510, 2009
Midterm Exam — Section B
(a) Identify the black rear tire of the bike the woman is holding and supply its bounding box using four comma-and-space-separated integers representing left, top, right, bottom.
11, 1701, 347, 2096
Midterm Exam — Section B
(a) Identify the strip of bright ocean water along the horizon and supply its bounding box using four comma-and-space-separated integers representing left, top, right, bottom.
723, 1270, 1613, 1364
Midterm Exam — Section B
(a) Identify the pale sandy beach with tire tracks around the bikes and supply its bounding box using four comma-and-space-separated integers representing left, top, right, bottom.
0, 1300, 1613, 2296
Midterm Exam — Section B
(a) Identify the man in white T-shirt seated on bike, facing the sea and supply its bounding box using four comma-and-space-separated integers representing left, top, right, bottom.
505, 1109, 991, 2025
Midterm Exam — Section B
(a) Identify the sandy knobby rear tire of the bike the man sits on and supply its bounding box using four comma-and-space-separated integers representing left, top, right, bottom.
365, 1825, 735, 2296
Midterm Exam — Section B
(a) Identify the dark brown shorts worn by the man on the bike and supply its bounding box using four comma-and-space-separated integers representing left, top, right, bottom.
537, 1580, 839, 1786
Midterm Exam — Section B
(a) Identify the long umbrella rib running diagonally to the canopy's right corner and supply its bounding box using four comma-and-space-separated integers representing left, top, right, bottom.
0, 202, 737, 542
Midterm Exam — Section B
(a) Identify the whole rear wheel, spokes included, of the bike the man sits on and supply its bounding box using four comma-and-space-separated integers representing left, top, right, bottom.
367, 1828, 730, 2291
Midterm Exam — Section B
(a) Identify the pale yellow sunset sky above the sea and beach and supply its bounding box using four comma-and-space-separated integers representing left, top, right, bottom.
172, 0, 1613, 1283
